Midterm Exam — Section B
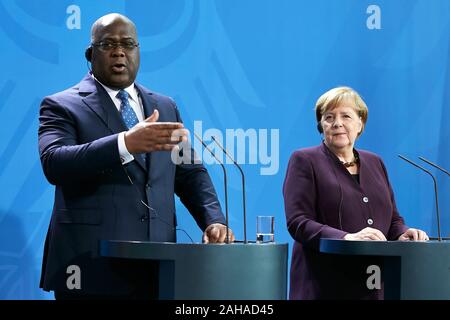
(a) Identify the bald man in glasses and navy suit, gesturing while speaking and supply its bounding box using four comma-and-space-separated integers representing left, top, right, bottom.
39, 14, 234, 299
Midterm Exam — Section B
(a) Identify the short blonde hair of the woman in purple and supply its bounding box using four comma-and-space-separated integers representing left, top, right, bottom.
315, 87, 369, 136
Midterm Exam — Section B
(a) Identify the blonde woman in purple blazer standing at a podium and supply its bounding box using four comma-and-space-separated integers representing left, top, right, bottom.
283, 87, 428, 299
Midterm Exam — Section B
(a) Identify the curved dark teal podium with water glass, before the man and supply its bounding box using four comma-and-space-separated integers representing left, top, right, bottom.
99, 240, 288, 300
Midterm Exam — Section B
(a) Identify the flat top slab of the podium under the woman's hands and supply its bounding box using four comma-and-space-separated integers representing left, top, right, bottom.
320, 239, 450, 256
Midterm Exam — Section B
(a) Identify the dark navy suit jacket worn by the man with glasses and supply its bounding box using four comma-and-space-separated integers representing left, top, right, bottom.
39, 74, 224, 294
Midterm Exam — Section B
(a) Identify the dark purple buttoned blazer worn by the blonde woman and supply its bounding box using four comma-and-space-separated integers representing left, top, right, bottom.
283, 143, 408, 299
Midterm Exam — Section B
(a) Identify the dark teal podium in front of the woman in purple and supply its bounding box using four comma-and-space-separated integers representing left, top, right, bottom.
320, 239, 450, 300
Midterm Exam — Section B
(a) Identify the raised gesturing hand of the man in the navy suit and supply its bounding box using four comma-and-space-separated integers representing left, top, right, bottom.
125, 109, 189, 153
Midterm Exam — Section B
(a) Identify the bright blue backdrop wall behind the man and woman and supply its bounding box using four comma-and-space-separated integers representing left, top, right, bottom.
0, 0, 450, 299
